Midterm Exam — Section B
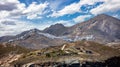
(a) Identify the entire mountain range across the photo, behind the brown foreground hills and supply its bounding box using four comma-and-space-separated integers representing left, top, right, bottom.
0, 14, 120, 49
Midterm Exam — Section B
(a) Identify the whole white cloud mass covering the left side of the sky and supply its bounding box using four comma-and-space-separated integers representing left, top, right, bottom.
0, 0, 48, 36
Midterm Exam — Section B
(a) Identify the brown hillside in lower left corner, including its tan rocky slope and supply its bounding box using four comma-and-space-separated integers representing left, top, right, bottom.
0, 43, 33, 67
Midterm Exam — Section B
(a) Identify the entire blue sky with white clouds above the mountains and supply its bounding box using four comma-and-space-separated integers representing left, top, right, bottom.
0, 0, 120, 36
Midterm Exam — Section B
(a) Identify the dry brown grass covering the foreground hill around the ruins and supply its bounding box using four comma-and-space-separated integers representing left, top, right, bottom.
11, 41, 120, 64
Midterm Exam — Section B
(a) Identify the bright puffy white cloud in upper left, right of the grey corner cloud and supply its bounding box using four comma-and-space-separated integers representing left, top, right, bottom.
23, 2, 48, 19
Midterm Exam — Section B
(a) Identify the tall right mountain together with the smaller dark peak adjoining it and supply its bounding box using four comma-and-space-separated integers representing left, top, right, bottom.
44, 14, 120, 43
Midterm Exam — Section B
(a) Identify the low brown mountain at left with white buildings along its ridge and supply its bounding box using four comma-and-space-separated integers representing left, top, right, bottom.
1, 29, 65, 49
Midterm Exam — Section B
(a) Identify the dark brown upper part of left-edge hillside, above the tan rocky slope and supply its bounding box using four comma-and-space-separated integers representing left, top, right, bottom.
0, 43, 32, 58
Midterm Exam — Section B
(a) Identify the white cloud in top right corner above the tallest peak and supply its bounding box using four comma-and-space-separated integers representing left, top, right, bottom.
90, 0, 120, 15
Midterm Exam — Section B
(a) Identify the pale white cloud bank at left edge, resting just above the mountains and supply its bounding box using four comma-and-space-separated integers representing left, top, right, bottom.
0, 19, 36, 36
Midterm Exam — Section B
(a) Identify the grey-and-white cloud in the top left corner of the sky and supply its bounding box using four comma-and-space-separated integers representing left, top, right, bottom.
0, 0, 25, 19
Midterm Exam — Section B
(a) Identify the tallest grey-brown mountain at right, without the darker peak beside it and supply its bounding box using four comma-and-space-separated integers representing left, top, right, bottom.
70, 14, 120, 43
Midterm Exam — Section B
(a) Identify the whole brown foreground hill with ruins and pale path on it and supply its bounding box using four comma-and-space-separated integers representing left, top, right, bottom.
13, 41, 120, 66
